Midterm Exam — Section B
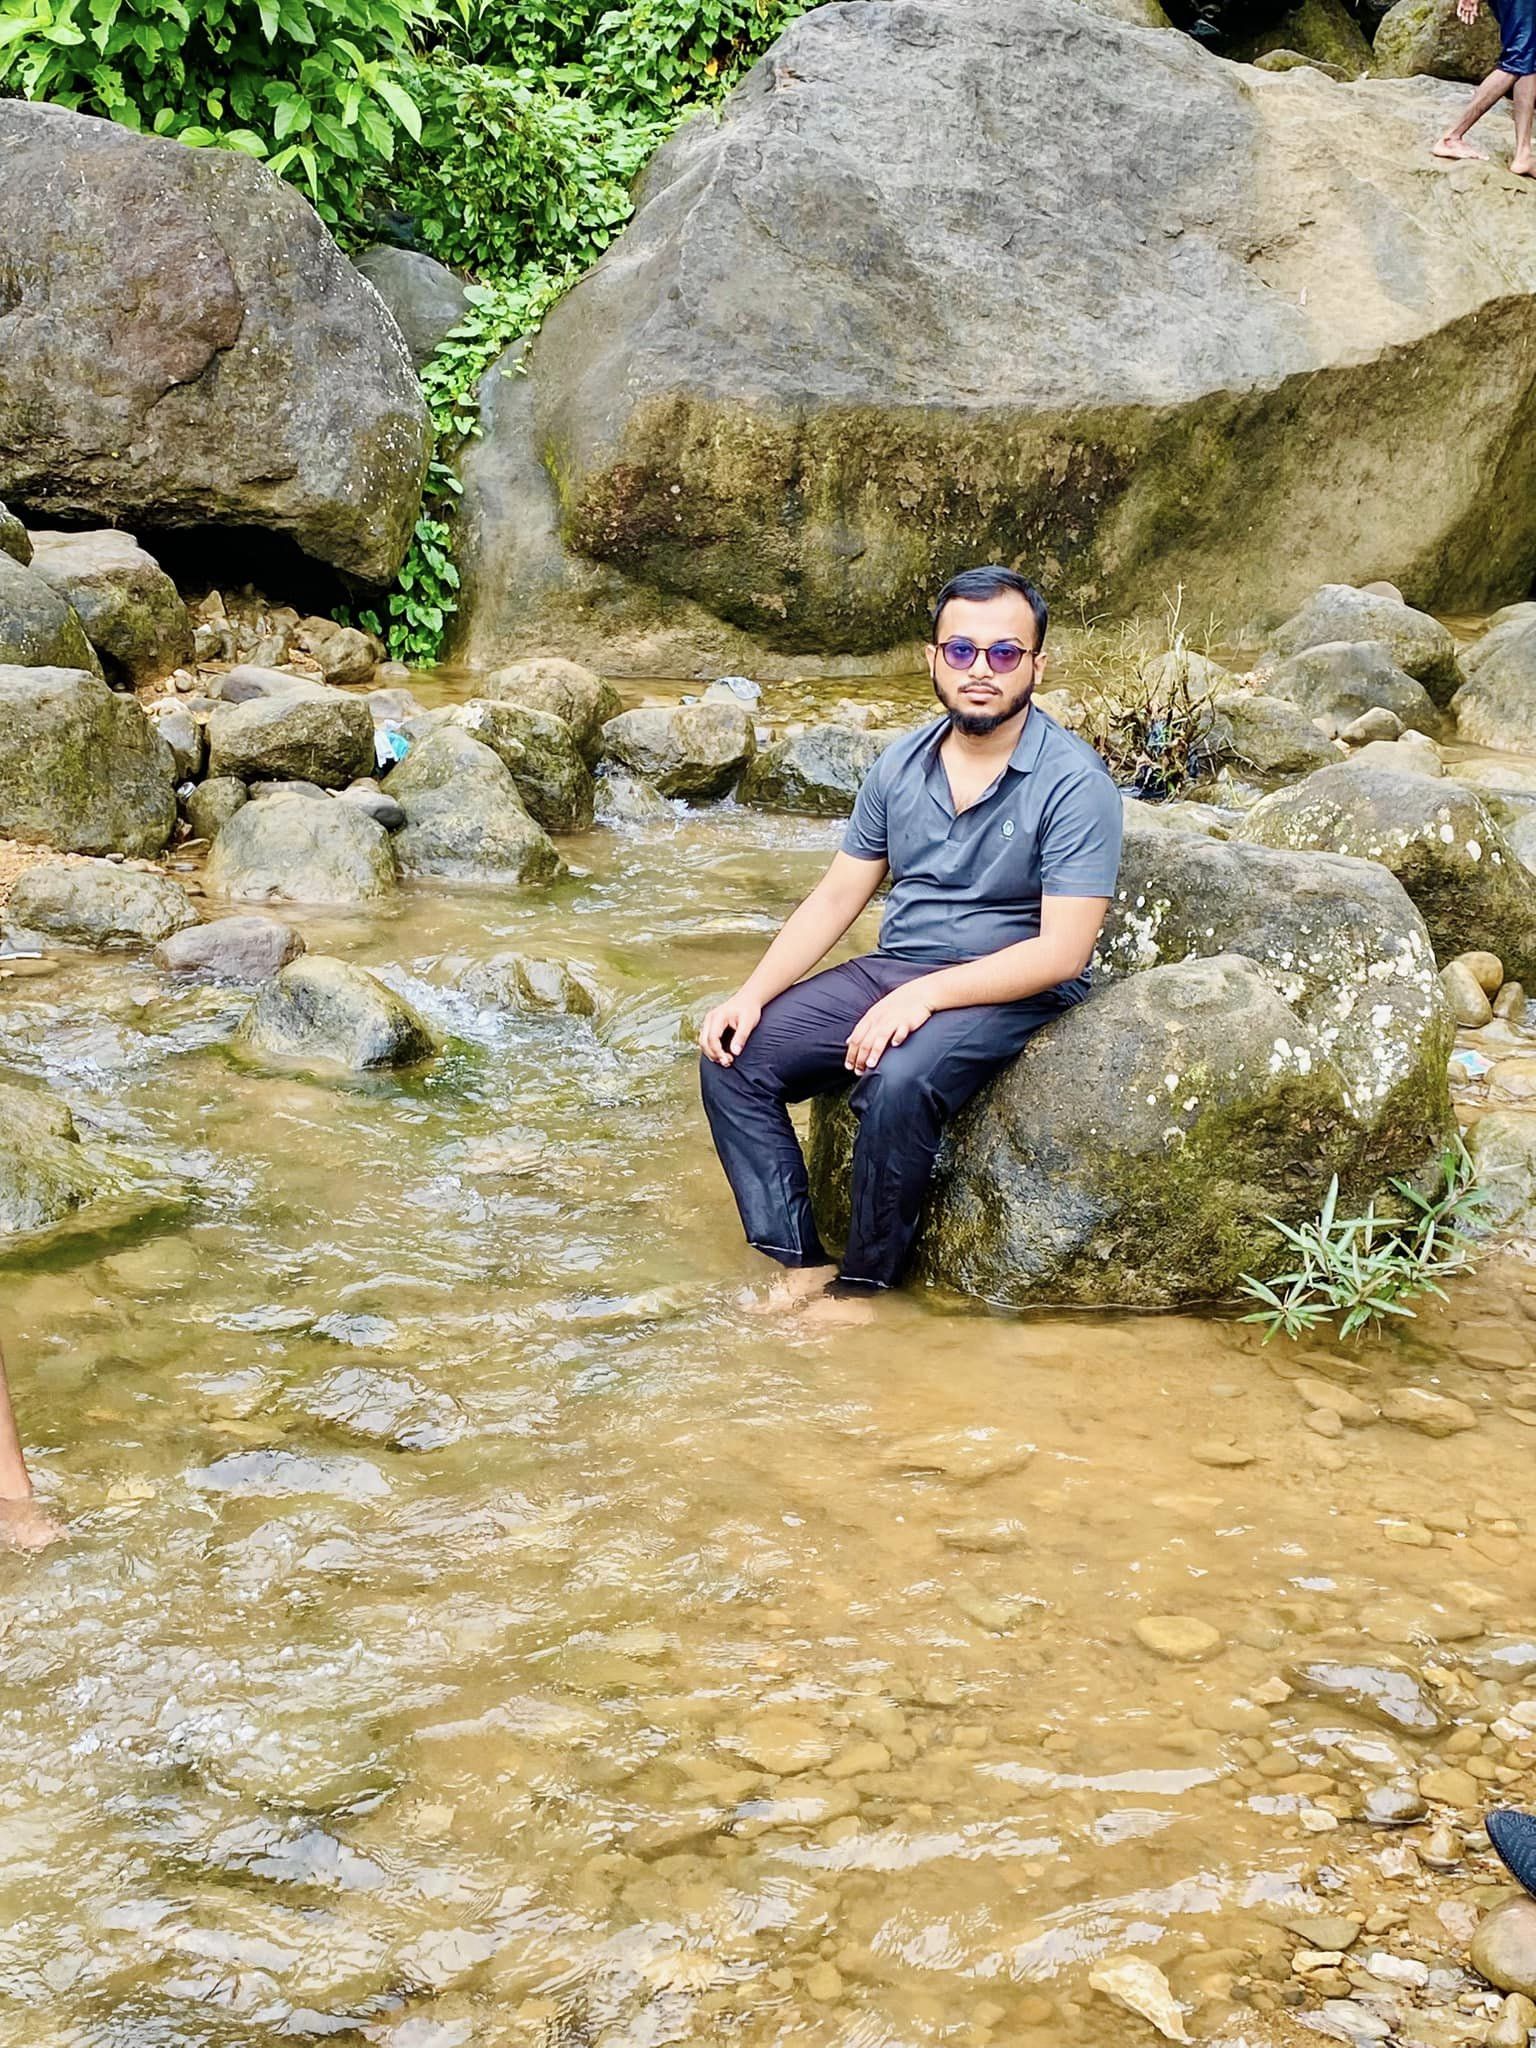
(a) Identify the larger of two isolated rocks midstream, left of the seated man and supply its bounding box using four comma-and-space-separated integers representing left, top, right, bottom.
236, 952, 438, 1073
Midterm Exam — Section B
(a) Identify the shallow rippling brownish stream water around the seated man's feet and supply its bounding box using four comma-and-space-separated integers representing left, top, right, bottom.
0, 675, 1536, 2048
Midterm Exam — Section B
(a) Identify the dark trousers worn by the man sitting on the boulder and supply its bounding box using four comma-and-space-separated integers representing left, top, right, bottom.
700, 952, 1073, 1288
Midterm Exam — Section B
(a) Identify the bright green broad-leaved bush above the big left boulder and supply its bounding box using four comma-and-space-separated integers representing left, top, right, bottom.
0, 0, 432, 225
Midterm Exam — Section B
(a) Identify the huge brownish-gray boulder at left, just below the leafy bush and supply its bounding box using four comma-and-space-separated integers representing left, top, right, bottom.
0, 100, 428, 584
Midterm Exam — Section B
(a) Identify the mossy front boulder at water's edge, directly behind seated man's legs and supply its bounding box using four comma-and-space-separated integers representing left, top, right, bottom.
813, 954, 1368, 1309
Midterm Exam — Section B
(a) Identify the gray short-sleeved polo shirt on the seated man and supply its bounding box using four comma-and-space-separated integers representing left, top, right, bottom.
842, 705, 1122, 993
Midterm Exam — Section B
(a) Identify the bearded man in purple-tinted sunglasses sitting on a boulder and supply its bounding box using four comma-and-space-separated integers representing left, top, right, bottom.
698, 567, 1120, 1303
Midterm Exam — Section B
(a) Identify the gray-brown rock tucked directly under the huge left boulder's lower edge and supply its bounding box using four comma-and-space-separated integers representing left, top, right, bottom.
33, 528, 193, 688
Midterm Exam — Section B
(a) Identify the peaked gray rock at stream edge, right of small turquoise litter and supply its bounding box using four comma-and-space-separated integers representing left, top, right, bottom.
385, 725, 561, 883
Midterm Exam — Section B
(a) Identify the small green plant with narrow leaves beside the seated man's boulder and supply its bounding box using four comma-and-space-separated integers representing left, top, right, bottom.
1243, 1143, 1487, 1343
